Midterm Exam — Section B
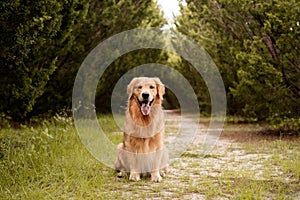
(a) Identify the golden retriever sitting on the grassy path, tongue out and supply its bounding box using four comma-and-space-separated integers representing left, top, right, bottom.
115, 77, 168, 182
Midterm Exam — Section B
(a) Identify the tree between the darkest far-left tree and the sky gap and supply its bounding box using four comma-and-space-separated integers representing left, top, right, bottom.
35, 0, 165, 117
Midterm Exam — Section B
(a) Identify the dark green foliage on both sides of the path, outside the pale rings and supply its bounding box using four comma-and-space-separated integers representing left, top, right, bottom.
0, 0, 300, 127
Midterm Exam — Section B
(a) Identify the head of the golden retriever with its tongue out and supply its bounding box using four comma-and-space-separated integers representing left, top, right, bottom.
127, 77, 165, 115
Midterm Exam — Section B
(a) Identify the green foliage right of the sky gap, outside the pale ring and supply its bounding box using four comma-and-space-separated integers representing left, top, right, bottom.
176, 0, 300, 120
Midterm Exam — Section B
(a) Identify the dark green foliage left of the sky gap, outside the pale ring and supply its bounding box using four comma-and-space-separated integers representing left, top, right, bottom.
0, 0, 164, 121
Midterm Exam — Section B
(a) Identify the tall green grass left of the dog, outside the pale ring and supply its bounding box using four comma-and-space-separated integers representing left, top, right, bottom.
0, 116, 122, 199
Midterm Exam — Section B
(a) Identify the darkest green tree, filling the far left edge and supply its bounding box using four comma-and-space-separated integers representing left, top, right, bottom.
0, 0, 87, 121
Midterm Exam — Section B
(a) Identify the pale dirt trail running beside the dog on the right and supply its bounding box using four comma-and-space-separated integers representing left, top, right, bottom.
155, 111, 298, 199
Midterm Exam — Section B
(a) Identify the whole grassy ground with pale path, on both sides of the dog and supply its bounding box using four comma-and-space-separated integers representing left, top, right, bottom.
0, 115, 300, 199
